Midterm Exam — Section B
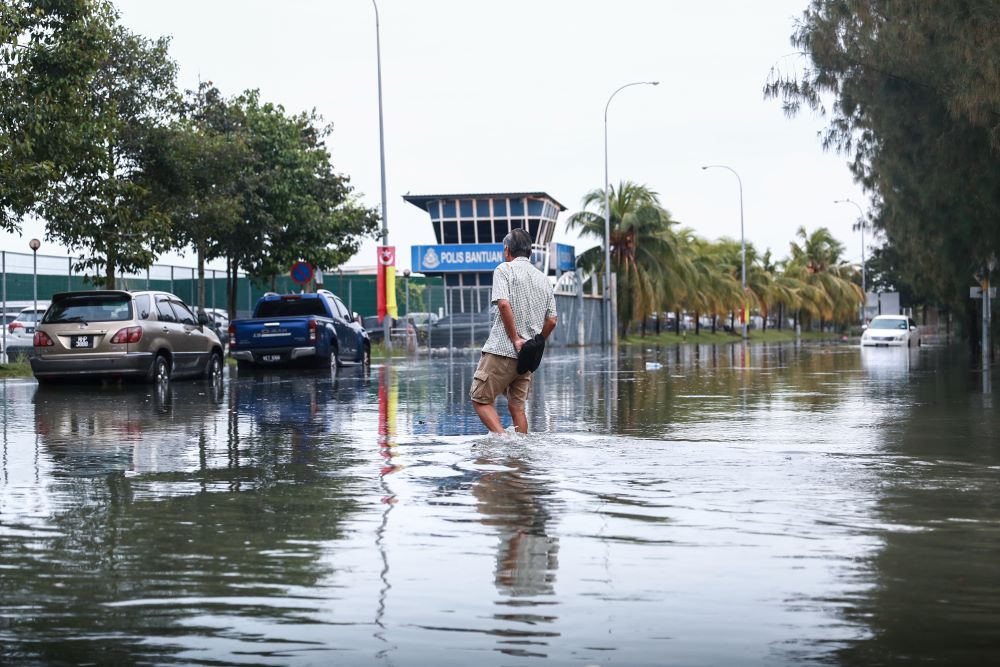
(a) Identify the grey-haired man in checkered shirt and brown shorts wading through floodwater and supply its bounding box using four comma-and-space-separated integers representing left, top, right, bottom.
469, 228, 556, 433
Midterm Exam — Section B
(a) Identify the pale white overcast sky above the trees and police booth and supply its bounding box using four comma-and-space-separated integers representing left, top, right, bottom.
2, 0, 867, 274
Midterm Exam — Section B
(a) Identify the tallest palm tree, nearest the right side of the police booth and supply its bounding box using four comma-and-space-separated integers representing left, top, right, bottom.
566, 181, 679, 331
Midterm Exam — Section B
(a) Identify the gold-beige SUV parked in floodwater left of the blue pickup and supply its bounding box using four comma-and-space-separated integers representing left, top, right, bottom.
31, 290, 222, 382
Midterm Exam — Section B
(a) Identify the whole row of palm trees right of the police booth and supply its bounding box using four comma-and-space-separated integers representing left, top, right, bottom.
567, 181, 863, 330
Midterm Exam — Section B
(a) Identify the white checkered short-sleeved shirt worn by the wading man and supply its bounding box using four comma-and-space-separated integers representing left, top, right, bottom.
483, 257, 556, 359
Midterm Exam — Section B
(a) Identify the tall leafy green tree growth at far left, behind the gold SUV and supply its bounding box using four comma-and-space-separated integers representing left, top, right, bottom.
2, 0, 176, 287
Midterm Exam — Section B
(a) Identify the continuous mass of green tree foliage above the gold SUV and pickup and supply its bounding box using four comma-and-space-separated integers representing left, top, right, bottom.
0, 0, 378, 300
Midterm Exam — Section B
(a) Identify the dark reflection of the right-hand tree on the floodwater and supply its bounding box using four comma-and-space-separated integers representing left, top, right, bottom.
838, 350, 1000, 665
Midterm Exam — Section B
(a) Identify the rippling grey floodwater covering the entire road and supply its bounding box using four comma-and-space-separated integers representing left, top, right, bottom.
0, 345, 1000, 667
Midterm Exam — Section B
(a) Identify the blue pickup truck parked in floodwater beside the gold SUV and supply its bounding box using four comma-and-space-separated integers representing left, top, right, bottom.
229, 290, 371, 367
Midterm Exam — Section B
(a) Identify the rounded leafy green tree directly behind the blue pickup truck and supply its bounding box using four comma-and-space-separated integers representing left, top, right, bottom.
157, 83, 378, 315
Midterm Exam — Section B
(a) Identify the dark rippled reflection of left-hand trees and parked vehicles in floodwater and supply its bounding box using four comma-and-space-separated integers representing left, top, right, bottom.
0, 378, 376, 664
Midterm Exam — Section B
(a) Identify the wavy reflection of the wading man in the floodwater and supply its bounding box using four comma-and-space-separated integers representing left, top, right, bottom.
472, 453, 559, 656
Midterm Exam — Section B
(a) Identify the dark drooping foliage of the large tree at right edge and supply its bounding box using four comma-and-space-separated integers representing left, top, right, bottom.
765, 0, 1000, 314
